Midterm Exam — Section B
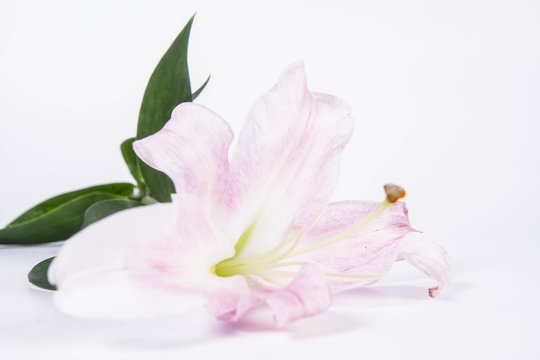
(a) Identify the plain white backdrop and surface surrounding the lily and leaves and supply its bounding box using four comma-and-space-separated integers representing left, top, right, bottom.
0, 0, 540, 359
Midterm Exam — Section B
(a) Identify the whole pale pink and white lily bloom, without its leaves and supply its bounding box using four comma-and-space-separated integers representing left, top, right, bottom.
48, 63, 450, 325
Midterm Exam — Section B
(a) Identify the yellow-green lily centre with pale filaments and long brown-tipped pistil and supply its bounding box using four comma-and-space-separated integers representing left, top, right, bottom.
214, 184, 405, 281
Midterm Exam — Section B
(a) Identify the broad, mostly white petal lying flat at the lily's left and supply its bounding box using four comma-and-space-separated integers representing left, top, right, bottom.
49, 195, 249, 317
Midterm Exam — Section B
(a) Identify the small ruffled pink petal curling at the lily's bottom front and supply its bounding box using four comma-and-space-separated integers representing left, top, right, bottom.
219, 263, 332, 326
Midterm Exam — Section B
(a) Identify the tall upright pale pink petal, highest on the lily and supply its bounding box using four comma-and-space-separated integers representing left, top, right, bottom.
224, 63, 353, 256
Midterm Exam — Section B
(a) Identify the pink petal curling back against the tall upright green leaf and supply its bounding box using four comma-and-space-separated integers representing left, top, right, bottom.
133, 103, 233, 207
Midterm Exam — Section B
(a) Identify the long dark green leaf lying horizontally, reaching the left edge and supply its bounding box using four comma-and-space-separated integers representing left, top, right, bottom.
0, 183, 134, 245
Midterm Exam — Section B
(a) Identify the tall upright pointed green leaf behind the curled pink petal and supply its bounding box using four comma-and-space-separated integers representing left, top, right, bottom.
137, 17, 204, 202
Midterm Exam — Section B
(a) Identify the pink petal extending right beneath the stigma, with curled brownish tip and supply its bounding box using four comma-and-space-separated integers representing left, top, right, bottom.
297, 201, 450, 296
